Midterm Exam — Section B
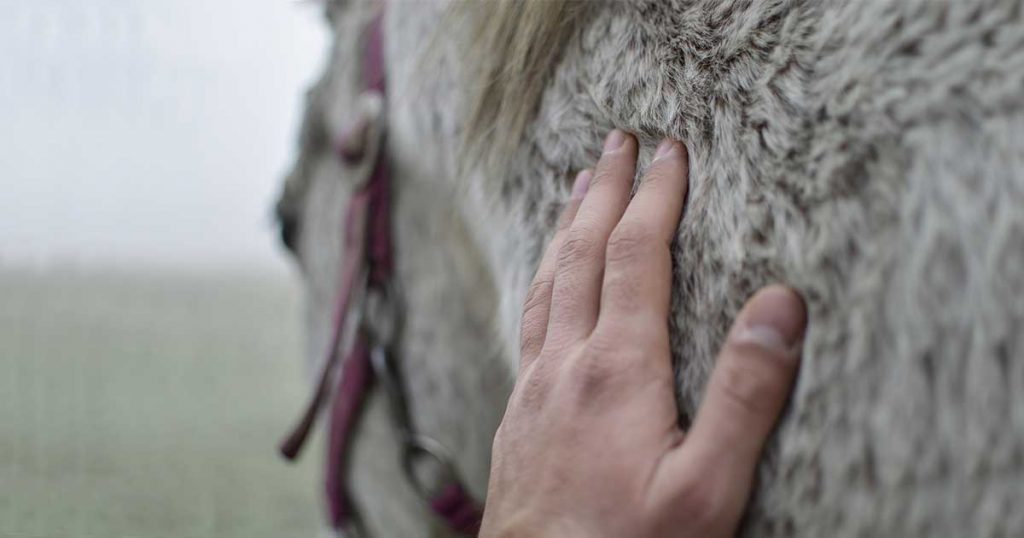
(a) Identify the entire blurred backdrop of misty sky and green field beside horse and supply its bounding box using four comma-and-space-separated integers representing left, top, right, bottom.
0, 0, 328, 538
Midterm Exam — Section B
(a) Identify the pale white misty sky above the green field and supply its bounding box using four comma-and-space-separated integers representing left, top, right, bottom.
0, 0, 328, 270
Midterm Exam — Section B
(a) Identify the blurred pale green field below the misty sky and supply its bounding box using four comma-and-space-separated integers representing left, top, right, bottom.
0, 270, 319, 538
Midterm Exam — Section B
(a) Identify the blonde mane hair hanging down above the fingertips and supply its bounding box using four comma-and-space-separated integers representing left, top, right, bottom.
445, 0, 587, 168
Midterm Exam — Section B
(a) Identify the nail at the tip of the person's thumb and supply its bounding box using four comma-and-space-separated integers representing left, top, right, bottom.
734, 286, 807, 359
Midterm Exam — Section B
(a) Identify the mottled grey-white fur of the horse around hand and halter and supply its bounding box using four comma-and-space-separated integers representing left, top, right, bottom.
279, 0, 1024, 537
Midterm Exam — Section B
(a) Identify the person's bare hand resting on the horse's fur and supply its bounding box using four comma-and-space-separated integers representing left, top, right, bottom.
480, 131, 807, 538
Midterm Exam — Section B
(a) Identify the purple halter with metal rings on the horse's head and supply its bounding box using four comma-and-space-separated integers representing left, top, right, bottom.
281, 8, 482, 536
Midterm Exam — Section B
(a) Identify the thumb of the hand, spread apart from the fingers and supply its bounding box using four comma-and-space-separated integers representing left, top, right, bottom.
659, 286, 807, 526
